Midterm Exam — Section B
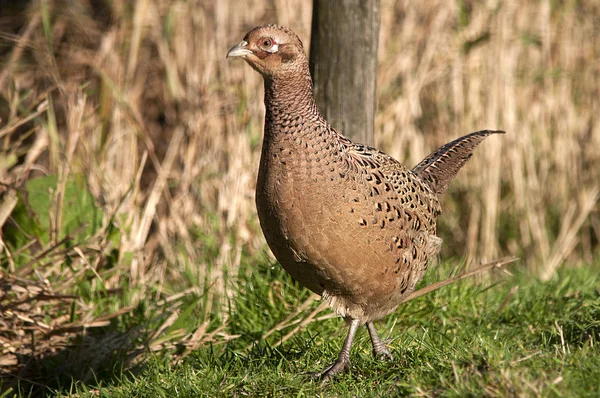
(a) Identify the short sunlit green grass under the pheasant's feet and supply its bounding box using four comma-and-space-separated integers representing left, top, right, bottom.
43, 264, 600, 397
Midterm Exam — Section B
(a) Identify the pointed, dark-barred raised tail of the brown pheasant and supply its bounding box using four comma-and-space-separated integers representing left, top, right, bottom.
412, 130, 504, 195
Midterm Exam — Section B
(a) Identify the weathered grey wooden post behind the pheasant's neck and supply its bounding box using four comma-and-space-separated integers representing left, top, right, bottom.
310, 0, 379, 145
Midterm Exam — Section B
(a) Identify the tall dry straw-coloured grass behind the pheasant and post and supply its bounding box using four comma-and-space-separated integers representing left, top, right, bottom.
0, 0, 600, 390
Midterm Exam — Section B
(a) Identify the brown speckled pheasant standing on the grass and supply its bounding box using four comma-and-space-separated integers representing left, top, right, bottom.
227, 25, 503, 380
